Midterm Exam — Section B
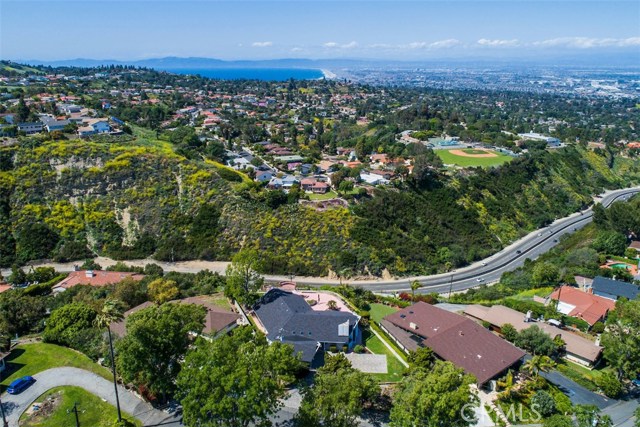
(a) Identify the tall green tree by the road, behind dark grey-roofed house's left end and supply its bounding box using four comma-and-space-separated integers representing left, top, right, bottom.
224, 249, 264, 305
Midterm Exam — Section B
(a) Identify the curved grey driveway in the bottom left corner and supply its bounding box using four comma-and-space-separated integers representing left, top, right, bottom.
2, 368, 180, 427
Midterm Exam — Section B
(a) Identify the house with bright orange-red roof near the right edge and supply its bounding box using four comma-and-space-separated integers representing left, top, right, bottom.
547, 286, 616, 326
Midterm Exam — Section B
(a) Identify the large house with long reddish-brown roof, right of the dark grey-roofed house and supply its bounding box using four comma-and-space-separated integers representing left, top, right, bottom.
380, 302, 525, 386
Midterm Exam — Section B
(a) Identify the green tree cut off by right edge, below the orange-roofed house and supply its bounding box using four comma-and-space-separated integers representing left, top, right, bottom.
602, 300, 640, 380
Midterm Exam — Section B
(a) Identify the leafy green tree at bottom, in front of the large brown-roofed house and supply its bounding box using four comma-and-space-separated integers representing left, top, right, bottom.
391, 361, 478, 427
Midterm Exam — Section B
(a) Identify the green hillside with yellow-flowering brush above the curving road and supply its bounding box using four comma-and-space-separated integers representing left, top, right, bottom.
0, 138, 640, 275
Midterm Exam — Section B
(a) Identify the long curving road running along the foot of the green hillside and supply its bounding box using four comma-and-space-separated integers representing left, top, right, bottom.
2, 187, 640, 294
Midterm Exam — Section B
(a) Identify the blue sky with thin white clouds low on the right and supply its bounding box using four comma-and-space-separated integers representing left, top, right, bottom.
0, 0, 640, 62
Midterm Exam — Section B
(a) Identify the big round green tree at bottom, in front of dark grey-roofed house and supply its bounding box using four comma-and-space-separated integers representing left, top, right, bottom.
177, 327, 300, 427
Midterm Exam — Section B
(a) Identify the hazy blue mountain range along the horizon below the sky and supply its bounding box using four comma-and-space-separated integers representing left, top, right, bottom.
15, 52, 640, 70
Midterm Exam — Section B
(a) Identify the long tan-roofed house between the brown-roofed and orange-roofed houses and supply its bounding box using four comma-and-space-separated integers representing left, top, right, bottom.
464, 304, 602, 367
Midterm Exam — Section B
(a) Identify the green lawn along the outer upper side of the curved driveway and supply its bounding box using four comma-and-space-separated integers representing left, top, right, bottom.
0, 343, 113, 391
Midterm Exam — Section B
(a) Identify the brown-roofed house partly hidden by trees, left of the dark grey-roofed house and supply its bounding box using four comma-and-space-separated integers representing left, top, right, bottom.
109, 295, 241, 338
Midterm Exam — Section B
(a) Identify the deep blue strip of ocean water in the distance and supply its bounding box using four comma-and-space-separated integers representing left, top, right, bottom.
162, 68, 324, 81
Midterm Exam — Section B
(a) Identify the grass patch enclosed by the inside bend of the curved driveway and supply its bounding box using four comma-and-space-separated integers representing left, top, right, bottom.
20, 387, 142, 427
